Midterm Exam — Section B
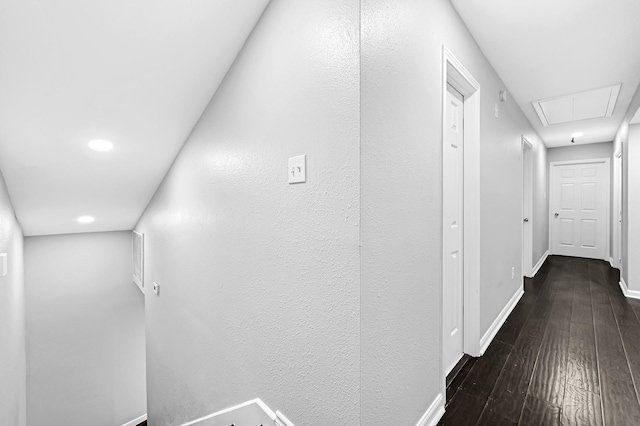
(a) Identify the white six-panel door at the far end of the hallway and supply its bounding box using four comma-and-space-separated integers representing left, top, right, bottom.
549, 159, 610, 260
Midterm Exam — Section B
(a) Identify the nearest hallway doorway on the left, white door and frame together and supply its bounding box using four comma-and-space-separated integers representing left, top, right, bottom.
441, 46, 481, 388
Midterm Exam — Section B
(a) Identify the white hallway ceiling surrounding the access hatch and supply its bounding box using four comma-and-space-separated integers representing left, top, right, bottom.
451, 0, 640, 147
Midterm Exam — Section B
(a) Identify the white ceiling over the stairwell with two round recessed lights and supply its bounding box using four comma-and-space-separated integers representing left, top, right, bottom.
0, 0, 269, 235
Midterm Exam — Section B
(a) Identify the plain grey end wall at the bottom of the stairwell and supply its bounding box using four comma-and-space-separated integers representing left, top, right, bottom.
25, 232, 146, 426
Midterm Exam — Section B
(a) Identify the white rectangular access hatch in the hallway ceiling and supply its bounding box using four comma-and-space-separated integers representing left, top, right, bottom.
532, 84, 622, 127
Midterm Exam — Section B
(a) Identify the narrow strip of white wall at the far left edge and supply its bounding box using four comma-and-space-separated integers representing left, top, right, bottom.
0, 169, 27, 426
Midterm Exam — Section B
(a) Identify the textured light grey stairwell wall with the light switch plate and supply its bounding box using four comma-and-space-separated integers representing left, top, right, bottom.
136, 0, 360, 426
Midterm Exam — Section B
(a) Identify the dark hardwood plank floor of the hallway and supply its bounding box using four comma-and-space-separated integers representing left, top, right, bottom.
438, 256, 640, 426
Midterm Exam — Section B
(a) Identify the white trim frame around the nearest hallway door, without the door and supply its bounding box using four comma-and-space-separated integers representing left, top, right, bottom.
440, 45, 481, 395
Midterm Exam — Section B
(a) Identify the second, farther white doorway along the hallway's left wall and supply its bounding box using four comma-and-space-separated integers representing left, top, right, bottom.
521, 135, 533, 278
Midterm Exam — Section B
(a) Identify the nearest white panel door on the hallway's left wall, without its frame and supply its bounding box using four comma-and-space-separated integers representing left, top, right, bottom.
442, 85, 464, 374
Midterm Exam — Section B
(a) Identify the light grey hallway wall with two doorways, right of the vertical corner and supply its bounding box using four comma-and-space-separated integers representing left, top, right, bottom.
360, 0, 548, 425
